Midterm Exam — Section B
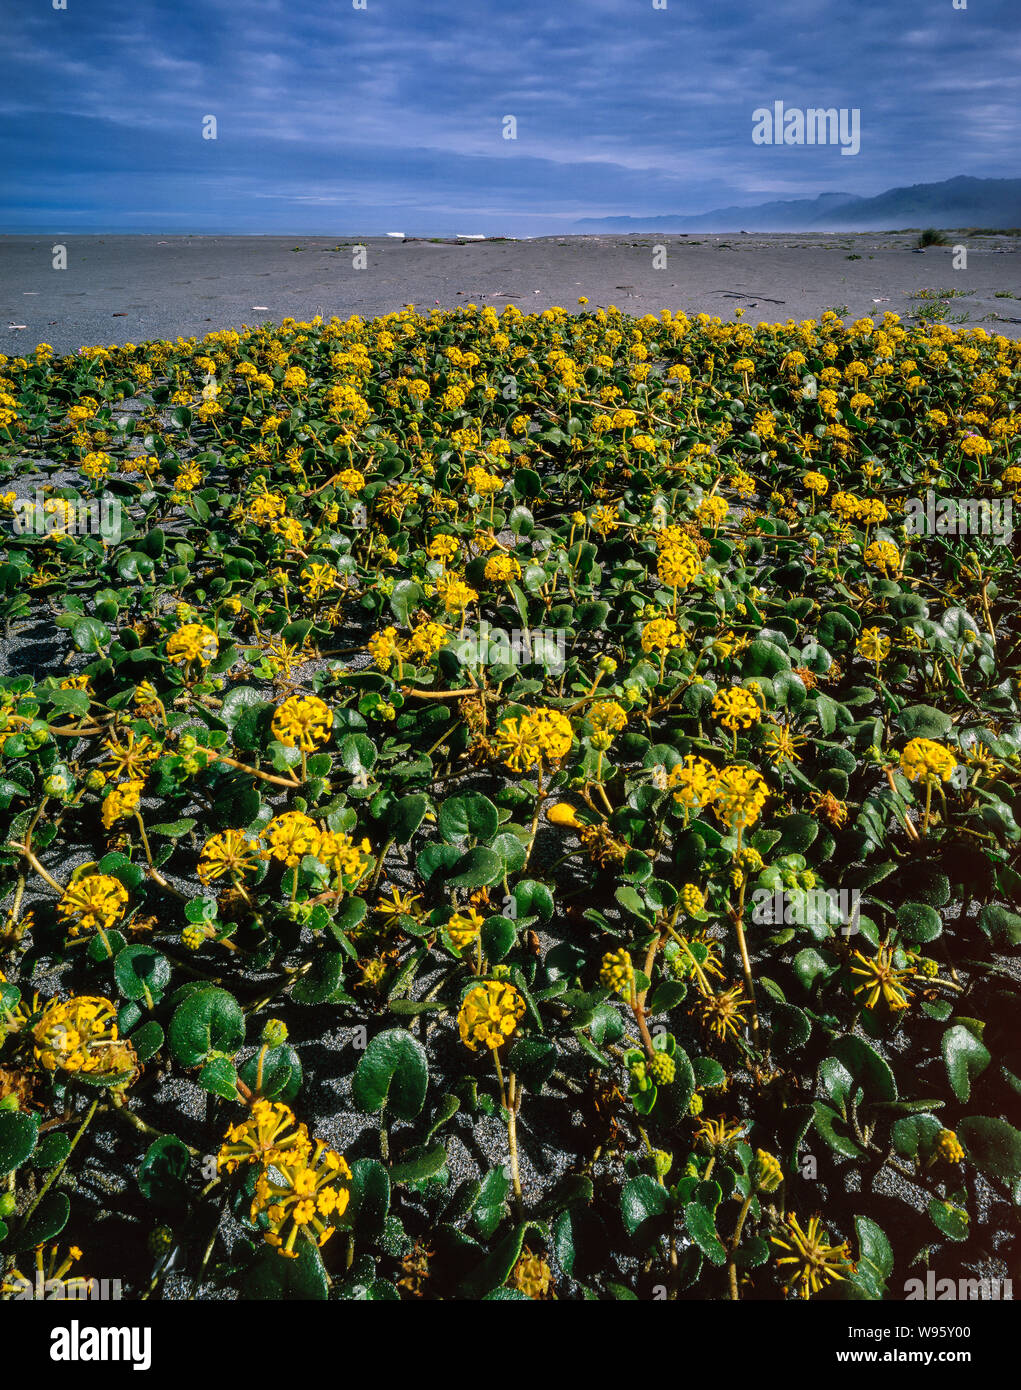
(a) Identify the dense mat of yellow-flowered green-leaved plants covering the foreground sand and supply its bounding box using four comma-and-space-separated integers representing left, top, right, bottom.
0, 306, 1021, 1300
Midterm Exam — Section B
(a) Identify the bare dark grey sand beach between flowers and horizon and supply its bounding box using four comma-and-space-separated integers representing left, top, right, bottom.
0, 232, 1021, 354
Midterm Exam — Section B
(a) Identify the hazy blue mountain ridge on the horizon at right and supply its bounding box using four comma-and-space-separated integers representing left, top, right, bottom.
574, 174, 1021, 232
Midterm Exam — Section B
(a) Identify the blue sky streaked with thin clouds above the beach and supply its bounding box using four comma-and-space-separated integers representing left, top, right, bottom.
0, 0, 1021, 236
